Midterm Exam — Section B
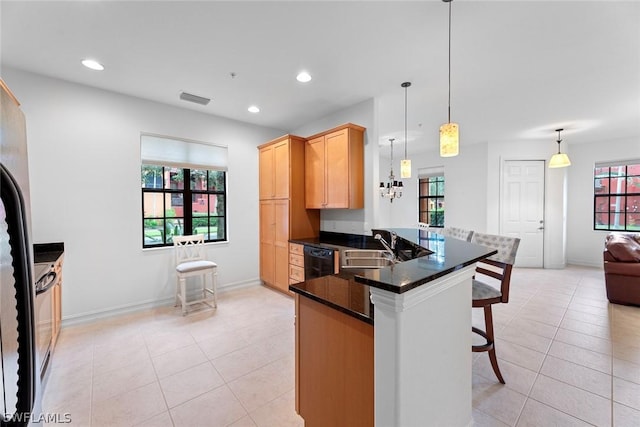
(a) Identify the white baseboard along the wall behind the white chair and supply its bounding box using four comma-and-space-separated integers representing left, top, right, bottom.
62, 279, 262, 327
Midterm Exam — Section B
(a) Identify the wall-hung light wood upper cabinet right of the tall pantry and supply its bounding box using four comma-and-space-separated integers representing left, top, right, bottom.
305, 123, 364, 209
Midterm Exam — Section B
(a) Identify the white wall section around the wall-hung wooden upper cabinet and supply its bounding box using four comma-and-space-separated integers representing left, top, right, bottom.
292, 99, 379, 235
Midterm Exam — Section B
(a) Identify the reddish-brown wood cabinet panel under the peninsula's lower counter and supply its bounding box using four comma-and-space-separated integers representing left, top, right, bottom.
295, 295, 374, 427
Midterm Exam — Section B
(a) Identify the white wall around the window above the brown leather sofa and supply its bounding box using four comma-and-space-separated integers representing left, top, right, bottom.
567, 138, 640, 268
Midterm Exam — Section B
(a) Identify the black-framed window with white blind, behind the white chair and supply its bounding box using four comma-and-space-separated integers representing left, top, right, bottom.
141, 135, 227, 248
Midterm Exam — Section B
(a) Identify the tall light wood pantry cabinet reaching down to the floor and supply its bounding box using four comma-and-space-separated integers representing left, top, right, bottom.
258, 135, 320, 292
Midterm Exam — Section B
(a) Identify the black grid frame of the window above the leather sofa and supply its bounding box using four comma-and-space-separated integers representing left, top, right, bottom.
592, 159, 640, 232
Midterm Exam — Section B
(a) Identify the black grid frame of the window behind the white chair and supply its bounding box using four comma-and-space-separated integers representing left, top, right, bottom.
140, 166, 229, 249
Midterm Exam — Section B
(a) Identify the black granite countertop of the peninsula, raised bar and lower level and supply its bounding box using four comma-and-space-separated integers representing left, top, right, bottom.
289, 228, 496, 324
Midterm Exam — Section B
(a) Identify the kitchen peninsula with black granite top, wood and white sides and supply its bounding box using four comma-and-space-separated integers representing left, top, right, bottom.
290, 229, 495, 427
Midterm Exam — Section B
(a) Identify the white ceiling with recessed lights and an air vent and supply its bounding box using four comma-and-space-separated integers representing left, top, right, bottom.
0, 0, 640, 152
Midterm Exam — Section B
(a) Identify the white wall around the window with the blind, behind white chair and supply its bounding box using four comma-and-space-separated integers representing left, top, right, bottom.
2, 67, 285, 321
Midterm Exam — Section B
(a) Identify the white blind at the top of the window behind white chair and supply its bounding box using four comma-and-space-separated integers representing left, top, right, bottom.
140, 134, 228, 171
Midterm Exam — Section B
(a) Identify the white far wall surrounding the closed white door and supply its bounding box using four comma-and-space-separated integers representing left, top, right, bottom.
380, 137, 566, 268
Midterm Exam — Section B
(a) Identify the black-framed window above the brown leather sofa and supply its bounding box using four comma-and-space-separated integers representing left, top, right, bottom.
593, 160, 640, 231
